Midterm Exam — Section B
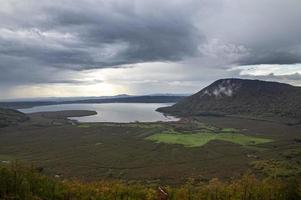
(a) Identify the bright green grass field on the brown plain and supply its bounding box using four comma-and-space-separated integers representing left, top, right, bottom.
146, 132, 273, 147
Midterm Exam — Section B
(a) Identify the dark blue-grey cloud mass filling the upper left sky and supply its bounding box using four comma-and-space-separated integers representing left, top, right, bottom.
0, 0, 202, 89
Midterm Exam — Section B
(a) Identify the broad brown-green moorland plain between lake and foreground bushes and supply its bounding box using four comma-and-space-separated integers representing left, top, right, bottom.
0, 111, 301, 184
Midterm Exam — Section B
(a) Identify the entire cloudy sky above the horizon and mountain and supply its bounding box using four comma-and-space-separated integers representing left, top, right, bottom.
0, 0, 301, 100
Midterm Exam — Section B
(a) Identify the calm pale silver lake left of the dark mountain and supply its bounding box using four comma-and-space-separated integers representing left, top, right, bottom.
19, 103, 178, 122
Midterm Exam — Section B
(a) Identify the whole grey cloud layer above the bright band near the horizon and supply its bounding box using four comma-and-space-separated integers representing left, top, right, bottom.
0, 0, 301, 92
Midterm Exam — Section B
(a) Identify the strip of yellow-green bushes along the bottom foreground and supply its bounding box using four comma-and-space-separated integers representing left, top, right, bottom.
0, 163, 301, 200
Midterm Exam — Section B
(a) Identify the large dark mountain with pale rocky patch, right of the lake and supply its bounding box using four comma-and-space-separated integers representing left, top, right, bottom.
158, 79, 301, 123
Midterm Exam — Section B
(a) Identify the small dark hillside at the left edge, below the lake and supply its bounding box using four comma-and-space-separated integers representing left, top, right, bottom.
0, 108, 29, 128
